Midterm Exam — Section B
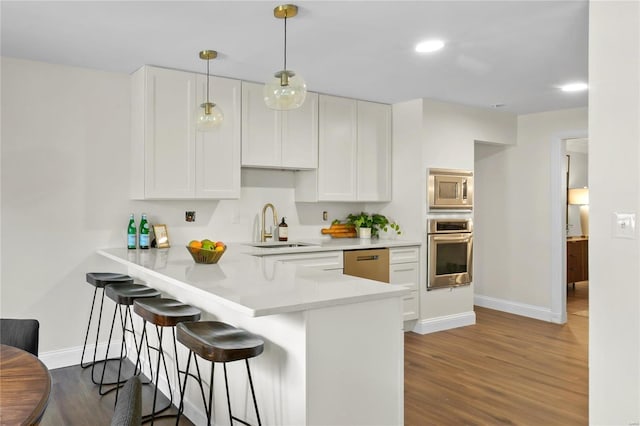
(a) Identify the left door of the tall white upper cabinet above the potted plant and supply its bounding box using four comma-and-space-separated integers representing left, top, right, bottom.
318, 95, 357, 201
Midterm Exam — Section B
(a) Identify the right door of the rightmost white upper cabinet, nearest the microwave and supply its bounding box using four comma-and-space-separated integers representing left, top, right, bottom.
357, 101, 391, 201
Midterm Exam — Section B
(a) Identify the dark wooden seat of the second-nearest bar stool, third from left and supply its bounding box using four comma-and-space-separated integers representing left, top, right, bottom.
133, 298, 201, 327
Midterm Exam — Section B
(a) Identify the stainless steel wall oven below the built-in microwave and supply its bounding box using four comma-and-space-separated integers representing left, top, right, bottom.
427, 219, 473, 290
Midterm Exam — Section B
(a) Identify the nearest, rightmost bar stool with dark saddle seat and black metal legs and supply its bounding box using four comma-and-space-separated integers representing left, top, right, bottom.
176, 321, 264, 426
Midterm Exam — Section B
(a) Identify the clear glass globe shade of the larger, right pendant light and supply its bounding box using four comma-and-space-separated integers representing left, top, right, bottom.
263, 70, 307, 111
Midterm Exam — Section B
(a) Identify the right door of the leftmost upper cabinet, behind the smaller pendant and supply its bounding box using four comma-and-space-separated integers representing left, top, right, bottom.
195, 75, 241, 199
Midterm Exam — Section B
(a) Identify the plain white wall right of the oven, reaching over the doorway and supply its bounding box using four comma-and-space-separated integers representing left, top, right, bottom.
474, 108, 587, 321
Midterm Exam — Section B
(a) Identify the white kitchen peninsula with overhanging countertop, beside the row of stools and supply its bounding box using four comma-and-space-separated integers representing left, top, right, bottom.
98, 243, 408, 425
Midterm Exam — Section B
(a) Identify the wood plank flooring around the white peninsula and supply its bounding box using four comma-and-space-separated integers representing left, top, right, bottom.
41, 283, 589, 426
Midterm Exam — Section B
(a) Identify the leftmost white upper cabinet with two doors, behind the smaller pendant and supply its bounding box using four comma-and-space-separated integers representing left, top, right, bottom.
131, 66, 240, 199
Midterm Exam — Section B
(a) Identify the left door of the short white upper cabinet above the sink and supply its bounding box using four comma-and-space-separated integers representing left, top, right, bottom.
242, 81, 282, 167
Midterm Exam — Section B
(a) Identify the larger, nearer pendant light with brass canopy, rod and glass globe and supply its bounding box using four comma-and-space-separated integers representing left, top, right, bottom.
264, 4, 307, 110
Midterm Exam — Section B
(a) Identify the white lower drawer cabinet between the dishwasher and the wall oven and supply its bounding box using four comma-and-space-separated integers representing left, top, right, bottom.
389, 247, 420, 321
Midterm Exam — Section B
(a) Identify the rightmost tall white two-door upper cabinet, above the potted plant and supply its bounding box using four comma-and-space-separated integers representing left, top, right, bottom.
296, 95, 391, 202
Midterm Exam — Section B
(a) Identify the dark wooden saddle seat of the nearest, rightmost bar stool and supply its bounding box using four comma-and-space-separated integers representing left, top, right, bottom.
176, 321, 264, 362
